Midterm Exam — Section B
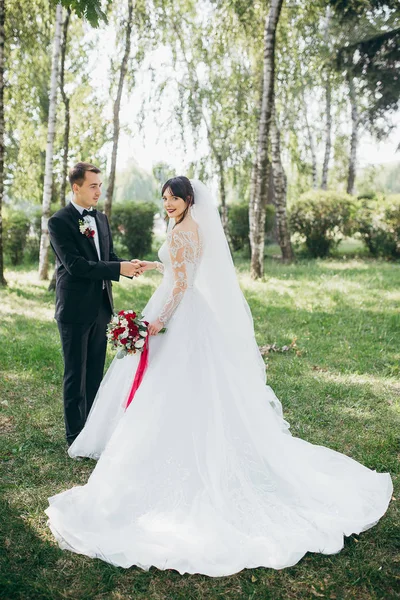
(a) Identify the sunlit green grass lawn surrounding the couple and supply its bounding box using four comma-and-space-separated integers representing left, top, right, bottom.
0, 257, 400, 600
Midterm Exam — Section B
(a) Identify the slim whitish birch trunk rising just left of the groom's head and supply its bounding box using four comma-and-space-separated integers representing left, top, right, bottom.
39, 4, 62, 279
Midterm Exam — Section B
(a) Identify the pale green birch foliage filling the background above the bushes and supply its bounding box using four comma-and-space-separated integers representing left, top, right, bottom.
3, 0, 400, 282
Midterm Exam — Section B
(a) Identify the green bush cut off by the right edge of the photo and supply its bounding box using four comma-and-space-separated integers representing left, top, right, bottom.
355, 195, 400, 259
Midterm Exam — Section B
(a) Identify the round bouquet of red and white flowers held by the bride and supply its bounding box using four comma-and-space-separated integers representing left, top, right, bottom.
107, 310, 148, 358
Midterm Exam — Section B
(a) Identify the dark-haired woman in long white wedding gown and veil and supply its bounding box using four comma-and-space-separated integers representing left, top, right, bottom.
46, 177, 392, 576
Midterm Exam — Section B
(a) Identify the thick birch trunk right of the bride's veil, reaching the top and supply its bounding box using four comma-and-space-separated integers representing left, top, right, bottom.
249, 0, 283, 279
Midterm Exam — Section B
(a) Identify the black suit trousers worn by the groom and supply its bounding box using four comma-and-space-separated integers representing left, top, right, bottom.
57, 289, 111, 444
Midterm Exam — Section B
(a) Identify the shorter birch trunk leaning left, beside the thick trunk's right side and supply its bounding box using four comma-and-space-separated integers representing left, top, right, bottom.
271, 101, 294, 262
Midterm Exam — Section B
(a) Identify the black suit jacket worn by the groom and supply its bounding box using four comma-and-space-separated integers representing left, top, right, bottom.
49, 203, 124, 323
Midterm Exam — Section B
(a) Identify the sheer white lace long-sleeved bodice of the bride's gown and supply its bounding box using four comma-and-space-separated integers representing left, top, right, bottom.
157, 230, 201, 323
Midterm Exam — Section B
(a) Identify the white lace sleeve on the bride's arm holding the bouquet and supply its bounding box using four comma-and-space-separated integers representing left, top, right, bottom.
159, 231, 193, 323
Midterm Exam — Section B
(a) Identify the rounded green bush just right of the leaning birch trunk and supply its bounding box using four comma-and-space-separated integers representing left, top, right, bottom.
289, 190, 355, 258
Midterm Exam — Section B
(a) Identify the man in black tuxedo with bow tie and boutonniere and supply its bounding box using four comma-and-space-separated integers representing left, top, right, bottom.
49, 162, 141, 445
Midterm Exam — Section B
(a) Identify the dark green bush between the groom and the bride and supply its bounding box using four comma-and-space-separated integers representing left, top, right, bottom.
111, 202, 158, 258
